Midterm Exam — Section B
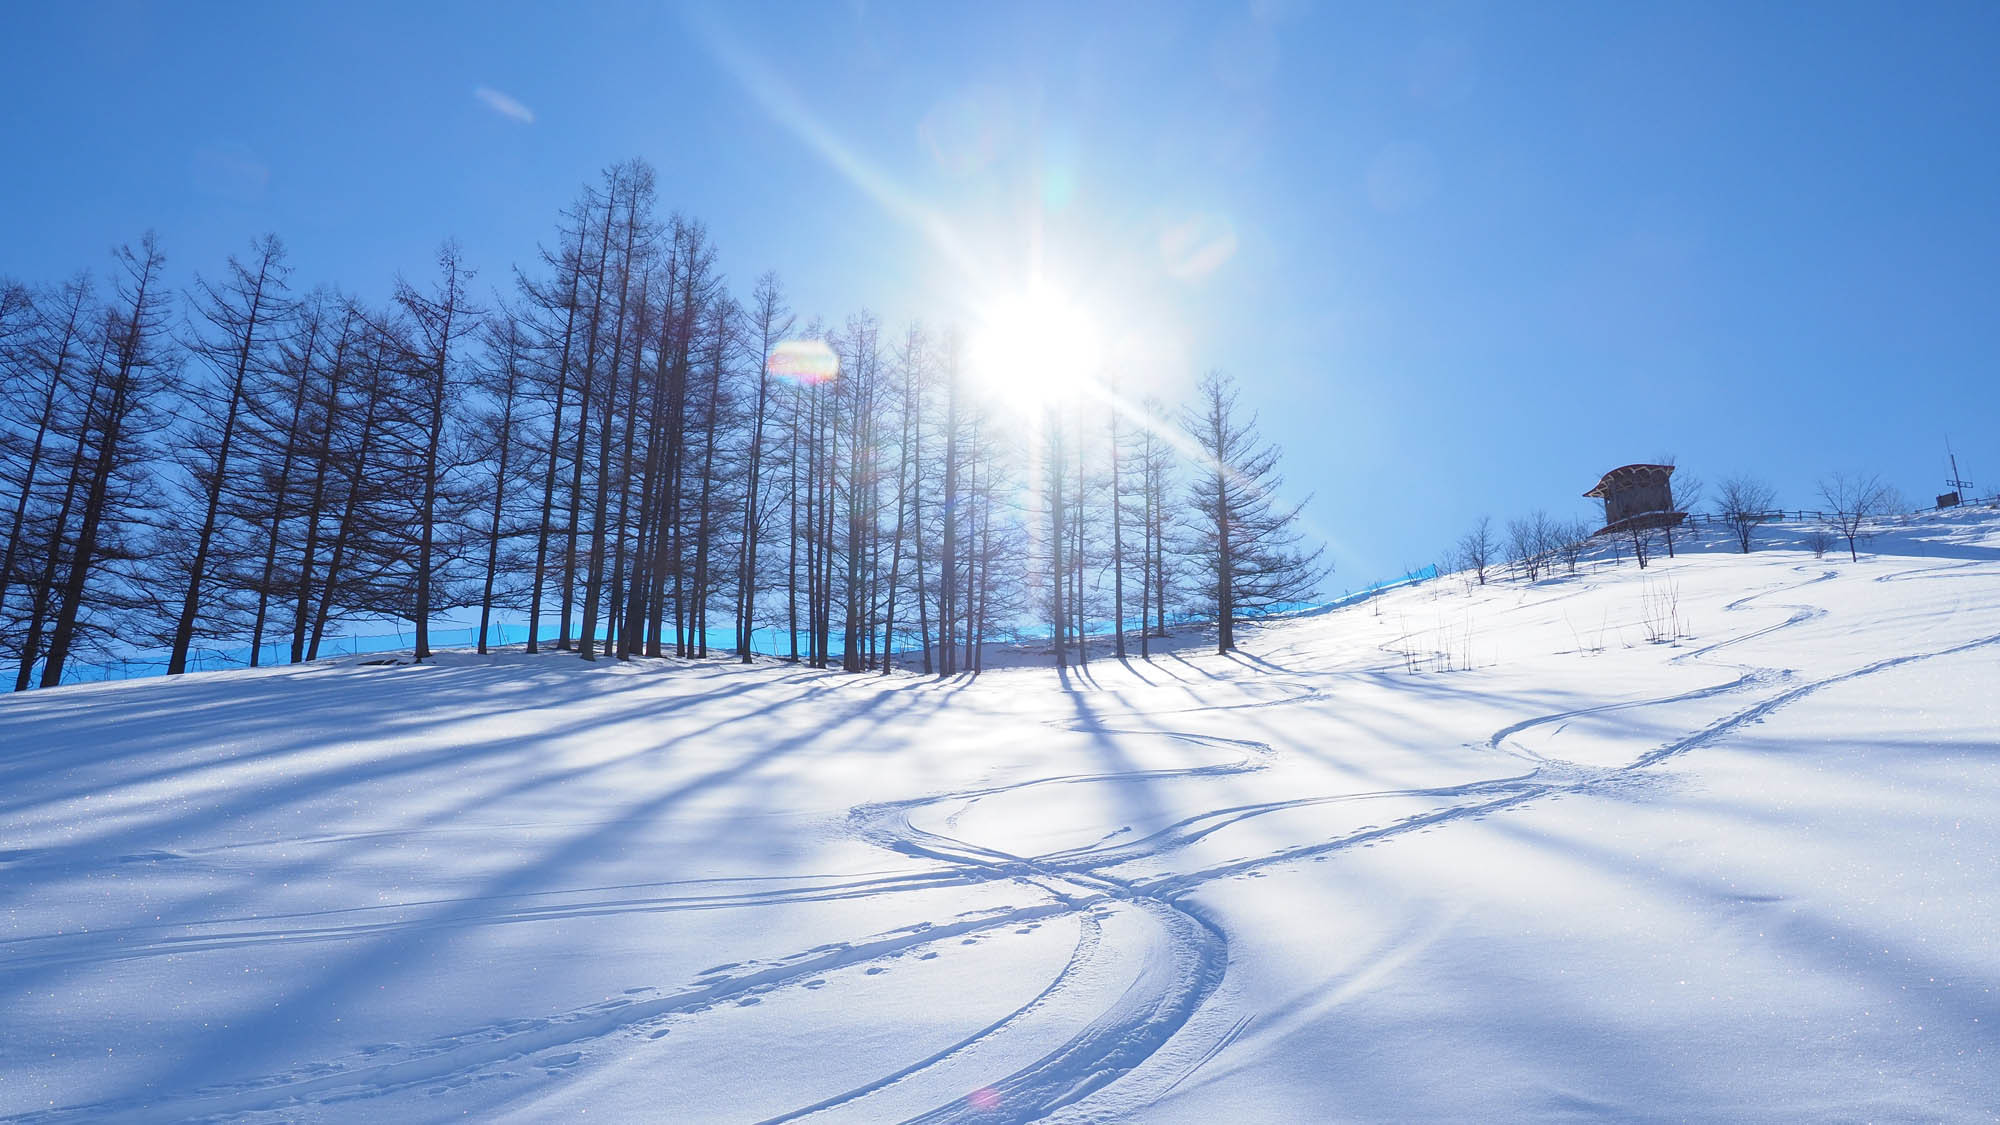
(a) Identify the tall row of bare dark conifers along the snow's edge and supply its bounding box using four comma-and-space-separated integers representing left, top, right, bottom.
0, 154, 1322, 691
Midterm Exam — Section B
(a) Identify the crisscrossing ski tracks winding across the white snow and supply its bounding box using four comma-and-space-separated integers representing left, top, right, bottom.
11, 560, 2000, 1125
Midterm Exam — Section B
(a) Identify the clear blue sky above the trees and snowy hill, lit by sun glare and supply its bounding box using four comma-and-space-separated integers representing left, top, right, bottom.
0, 2, 2000, 576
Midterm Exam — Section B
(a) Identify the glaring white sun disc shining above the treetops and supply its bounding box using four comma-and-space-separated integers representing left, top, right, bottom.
966, 286, 1104, 414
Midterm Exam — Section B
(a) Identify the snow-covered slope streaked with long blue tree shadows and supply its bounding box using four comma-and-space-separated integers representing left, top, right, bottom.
0, 512, 2000, 1123
